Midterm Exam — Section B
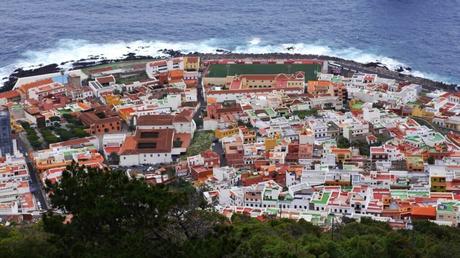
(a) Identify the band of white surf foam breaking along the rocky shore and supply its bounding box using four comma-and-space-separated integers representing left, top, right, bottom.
0, 37, 449, 86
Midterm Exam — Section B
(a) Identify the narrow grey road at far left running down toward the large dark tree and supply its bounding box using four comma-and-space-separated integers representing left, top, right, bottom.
17, 133, 51, 210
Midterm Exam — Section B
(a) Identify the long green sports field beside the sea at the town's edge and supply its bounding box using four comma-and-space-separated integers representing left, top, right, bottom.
206, 64, 321, 81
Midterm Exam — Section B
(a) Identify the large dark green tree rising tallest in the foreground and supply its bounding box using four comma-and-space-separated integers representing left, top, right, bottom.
43, 164, 222, 257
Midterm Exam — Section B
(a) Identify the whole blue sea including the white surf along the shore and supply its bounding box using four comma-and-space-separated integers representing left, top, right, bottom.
0, 0, 460, 83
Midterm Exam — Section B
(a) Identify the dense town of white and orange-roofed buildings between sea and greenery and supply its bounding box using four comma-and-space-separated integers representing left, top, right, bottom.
0, 55, 460, 228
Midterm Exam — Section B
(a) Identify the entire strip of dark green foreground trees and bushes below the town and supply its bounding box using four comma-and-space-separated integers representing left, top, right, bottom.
0, 166, 460, 257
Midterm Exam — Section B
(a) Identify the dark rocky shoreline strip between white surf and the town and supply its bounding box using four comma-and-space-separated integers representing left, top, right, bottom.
0, 49, 457, 92
